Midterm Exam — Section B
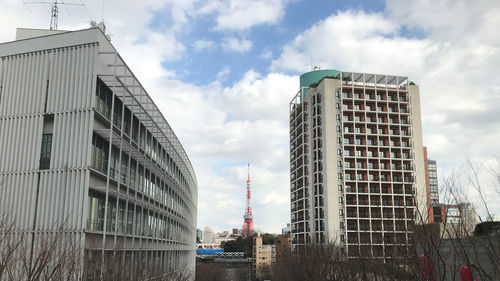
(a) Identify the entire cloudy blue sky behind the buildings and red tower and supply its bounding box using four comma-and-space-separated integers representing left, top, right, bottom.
0, 0, 500, 233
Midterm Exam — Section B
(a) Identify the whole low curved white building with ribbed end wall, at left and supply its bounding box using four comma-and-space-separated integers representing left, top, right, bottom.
0, 25, 198, 280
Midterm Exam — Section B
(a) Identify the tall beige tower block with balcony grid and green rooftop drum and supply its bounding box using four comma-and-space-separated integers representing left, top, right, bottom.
290, 70, 426, 257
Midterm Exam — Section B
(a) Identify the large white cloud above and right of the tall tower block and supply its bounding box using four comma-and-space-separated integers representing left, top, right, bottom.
271, 3, 500, 215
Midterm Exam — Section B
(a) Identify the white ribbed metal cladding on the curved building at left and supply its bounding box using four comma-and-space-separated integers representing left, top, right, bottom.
0, 26, 197, 278
